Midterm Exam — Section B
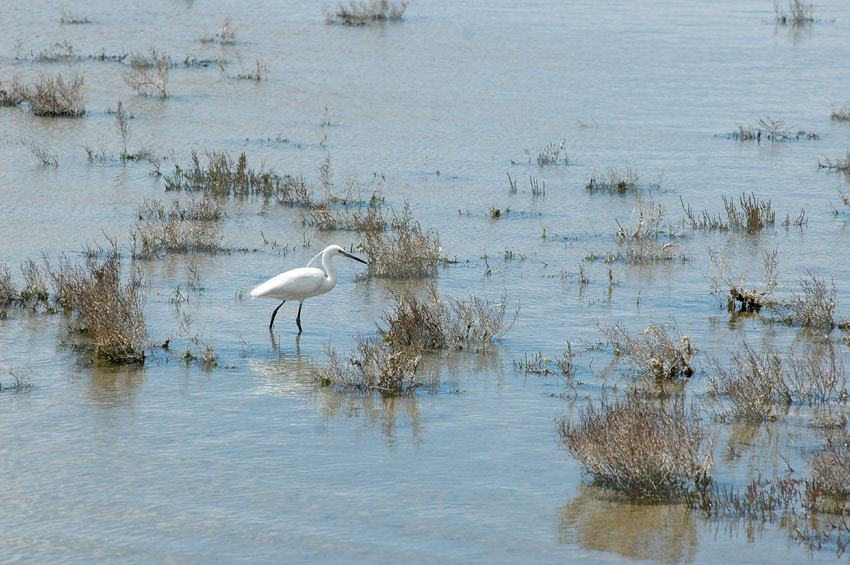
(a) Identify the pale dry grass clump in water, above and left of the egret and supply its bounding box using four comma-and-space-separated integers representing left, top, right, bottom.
131, 195, 223, 259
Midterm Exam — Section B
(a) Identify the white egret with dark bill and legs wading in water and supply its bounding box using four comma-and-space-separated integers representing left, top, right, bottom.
245, 245, 366, 333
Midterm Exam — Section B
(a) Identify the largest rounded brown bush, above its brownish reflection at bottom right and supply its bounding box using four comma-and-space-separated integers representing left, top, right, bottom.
558, 396, 712, 502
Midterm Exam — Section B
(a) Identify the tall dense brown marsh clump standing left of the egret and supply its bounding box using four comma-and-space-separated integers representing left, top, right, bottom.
51, 243, 147, 364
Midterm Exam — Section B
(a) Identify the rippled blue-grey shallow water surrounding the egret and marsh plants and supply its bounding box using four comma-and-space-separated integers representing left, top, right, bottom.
0, 0, 850, 562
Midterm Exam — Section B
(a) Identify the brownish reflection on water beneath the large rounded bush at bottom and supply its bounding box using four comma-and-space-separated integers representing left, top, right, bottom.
557, 486, 699, 563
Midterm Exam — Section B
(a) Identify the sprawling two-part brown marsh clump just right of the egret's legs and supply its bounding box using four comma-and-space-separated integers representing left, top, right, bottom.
315, 287, 512, 396
